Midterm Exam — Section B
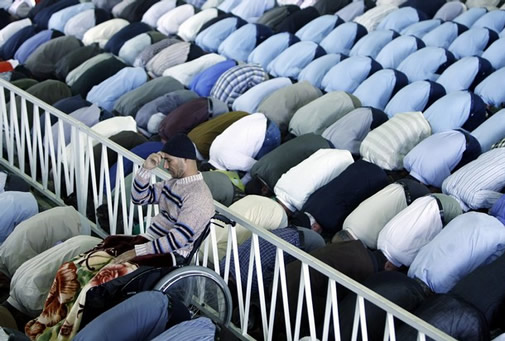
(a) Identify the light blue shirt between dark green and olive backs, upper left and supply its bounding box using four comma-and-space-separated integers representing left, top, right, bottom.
86, 67, 148, 111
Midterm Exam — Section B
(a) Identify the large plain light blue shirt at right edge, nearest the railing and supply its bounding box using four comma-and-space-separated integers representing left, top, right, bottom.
408, 212, 505, 294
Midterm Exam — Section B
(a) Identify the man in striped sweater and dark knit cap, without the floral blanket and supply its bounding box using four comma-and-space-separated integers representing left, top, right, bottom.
123, 134, 214, 263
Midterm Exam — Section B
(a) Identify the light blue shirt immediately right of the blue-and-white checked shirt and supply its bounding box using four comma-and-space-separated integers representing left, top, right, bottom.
233, 77, 291, 114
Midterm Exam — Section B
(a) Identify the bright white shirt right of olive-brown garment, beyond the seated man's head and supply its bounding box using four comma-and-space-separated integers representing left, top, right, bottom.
209, 113, 267, 172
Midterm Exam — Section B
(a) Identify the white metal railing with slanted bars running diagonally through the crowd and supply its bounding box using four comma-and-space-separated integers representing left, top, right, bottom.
0, 79, 454, 340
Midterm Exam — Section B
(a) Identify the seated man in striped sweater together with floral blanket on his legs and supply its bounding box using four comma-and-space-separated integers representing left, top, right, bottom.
25, 135, 214, 339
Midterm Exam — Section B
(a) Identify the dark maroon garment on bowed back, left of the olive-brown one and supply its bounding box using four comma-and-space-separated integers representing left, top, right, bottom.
159, 97, 209, 140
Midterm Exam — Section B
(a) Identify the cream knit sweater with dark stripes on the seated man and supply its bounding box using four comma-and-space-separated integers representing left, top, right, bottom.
132, 168, 214, 257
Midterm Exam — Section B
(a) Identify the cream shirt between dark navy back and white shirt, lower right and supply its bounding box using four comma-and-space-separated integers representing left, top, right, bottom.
342, 183, 407, 249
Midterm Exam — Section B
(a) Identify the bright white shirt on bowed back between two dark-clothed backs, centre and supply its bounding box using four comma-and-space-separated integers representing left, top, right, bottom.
274, 149, 354, 211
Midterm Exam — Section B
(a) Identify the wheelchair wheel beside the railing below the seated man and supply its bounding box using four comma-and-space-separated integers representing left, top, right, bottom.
154, 265, 232, 325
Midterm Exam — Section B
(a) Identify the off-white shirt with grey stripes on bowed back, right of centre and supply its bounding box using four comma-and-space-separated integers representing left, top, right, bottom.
359, 112, 431, 170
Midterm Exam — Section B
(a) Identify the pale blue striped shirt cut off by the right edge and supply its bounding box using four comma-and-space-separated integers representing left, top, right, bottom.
442, 148, 505, 211
